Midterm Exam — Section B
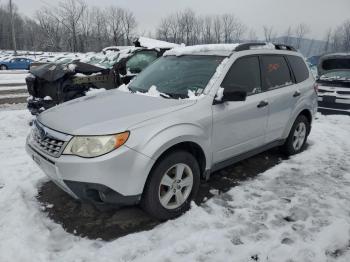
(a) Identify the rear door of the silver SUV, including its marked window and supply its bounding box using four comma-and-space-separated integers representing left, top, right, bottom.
260, 55, 300, 143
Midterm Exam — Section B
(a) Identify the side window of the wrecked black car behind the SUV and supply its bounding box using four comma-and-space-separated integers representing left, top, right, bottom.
126, 51, 157, 73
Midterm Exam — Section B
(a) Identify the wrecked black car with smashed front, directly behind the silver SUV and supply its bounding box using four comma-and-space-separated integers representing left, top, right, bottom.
26, 37, 177, 115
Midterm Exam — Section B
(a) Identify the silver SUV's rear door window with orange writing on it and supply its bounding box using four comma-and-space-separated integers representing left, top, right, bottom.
261, 55, 293, 90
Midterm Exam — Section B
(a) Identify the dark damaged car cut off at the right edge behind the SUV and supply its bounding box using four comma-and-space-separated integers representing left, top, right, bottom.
317, 53, 350, 115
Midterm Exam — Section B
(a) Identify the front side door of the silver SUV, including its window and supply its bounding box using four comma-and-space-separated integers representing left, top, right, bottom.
212, 56, 268, 163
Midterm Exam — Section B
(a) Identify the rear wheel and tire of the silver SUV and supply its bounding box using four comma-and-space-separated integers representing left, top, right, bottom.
282, 115, 311, 156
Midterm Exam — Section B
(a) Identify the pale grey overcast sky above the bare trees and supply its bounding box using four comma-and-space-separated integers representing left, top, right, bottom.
9, 0, 350, 39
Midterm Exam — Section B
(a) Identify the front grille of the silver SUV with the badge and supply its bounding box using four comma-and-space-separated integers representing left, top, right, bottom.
32, 124, 65, 157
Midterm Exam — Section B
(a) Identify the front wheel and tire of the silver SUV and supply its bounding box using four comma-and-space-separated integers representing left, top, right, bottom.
141, 150, 200, 221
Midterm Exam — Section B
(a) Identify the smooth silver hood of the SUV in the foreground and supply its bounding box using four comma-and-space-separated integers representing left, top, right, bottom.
38, 90, 195, 135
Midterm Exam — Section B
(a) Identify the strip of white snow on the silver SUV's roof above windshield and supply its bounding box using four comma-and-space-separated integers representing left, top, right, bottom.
164, 44, 240, 56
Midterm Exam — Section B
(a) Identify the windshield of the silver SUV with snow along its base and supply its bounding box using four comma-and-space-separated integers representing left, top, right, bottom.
129, 55, 224, 98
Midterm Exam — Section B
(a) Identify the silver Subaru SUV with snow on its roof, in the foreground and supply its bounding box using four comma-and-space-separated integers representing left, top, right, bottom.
26, 43, 317, 220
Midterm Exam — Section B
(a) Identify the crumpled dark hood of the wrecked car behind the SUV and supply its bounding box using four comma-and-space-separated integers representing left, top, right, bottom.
29, 61, 106, 82
